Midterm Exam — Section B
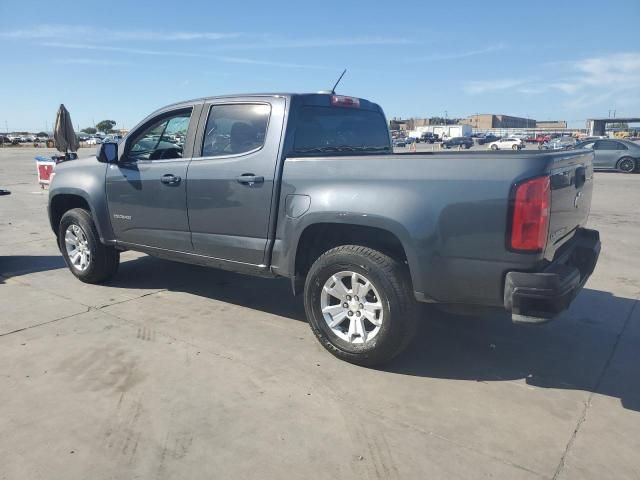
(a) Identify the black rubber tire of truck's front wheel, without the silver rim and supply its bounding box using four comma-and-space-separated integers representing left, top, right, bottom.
58, 208, 120, 283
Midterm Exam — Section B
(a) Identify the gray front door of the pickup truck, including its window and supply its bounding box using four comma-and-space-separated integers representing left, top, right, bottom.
106, 107, 197, 252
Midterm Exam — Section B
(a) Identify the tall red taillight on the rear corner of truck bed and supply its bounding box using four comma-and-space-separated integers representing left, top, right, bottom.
511, 177, 551, 252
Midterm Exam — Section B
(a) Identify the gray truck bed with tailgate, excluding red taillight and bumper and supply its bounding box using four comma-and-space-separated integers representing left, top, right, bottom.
274, 151, 593, 305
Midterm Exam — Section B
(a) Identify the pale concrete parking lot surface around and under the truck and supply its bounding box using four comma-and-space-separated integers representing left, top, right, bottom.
0, 146, 640, 480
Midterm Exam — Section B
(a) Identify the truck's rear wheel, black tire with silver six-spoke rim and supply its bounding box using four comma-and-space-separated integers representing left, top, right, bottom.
304, 245, 417, 367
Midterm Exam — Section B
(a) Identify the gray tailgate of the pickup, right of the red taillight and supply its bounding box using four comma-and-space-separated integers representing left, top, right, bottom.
545, 150, 593, 259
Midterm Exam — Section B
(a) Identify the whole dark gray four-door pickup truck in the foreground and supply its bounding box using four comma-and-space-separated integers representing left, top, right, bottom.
49, 93, 600, 366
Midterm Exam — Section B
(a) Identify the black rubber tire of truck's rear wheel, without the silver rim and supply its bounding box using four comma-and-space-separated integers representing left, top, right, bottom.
304, 245, 418, 367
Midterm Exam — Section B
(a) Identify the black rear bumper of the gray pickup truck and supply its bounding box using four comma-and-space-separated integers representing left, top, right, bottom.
504, 228, 600, 323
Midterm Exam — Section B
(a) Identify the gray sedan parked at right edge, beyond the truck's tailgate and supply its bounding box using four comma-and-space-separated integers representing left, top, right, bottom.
574, 139, 640, 173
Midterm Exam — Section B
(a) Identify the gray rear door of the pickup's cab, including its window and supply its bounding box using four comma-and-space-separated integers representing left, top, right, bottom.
187, 97, 286, 265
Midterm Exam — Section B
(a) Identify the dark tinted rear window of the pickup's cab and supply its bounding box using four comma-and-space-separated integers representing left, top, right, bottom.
294, 106, 391, 153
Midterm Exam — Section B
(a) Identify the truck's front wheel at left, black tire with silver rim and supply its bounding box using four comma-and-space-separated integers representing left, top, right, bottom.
58, 208, 120, 283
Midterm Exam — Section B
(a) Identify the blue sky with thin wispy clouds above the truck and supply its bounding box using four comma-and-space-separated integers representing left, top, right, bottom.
0, 0, 640, 131
